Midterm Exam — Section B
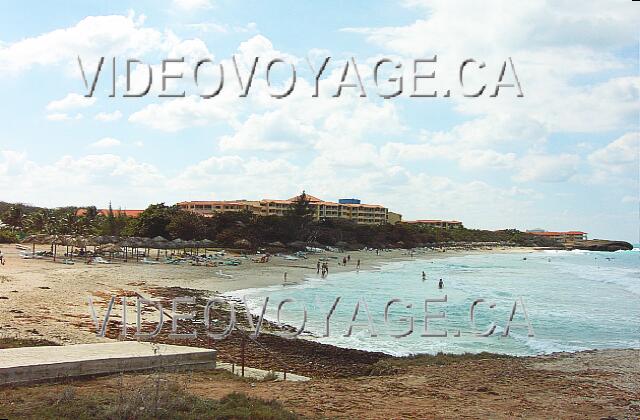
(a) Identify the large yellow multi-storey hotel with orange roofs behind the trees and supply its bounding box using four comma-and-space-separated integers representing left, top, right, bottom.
177, 195, 401, 225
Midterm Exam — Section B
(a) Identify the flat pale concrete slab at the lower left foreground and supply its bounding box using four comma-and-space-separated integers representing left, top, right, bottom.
0, 341, 216, 385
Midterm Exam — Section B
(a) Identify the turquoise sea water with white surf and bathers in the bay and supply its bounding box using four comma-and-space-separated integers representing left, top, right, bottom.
233, 248, 640, 355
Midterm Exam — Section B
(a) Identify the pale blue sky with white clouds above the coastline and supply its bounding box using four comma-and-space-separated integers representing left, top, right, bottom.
0, 0, 640, 243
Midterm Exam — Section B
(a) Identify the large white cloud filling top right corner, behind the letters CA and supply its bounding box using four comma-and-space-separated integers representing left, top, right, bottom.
345, 0, 640, 132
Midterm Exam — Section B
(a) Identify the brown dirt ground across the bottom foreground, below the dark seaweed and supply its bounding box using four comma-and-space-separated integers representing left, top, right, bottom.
0, 350, 640, 419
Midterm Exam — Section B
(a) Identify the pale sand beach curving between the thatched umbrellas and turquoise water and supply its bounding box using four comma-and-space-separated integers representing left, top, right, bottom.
0, 245, 532, 344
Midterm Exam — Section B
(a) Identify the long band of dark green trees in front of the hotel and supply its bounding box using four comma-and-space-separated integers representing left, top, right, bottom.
0, 192, 556, 249
